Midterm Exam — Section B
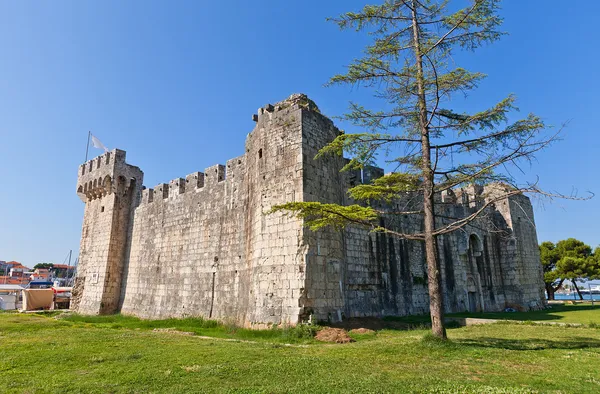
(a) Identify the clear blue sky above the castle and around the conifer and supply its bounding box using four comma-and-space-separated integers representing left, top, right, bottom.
0, 0, 600, 266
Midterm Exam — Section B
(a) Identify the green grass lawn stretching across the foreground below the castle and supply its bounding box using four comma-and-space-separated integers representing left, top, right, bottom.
0, 305, 600, 393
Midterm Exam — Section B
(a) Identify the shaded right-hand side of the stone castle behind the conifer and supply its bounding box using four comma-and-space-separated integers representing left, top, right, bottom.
303, 113, 543, 321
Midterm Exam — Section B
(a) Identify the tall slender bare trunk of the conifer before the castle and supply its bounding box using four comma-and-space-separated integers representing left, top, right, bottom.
412, 0, 447, 339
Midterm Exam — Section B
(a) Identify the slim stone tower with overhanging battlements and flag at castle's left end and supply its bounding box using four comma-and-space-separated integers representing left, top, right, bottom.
72, 149, 143, 314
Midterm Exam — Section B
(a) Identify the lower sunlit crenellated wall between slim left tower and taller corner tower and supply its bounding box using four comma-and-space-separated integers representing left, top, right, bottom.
121, 163, 249, 318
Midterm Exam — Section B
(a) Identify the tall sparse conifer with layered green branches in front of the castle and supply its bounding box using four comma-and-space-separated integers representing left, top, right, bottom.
274, 0, 580, 339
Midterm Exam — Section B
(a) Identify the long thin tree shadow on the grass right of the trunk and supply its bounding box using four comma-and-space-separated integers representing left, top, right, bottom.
453, 337, 600, 350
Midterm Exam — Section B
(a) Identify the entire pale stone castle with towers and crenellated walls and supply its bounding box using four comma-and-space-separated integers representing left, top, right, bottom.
72, 95, 544, 327
